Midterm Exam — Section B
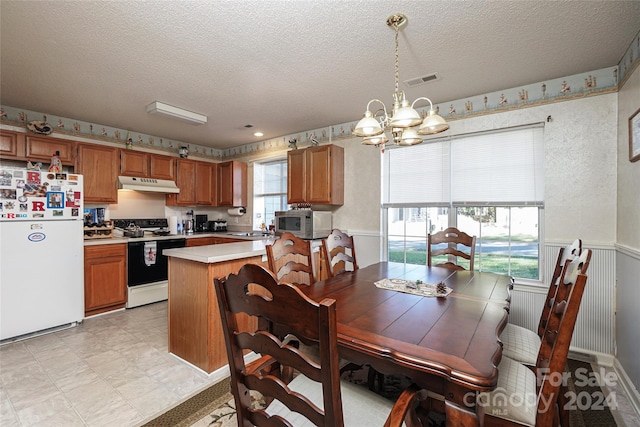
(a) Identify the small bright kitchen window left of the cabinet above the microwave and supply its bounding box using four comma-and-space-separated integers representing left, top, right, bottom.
253, 159, 288, 228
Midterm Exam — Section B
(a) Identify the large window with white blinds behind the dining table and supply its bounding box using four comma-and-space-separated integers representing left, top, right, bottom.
382, 126, 544, 279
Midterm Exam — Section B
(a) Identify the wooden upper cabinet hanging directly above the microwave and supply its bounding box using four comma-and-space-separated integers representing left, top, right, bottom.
287, 145, 344, 205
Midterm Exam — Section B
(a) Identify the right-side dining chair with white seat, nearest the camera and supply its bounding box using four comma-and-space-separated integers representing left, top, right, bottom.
477, 249, 591, 427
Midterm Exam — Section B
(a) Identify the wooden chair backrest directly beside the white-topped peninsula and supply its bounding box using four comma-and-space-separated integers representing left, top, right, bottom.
266, 232, 316, 285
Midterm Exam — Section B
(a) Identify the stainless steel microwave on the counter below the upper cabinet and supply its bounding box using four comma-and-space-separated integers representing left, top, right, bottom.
275, 209, 332, 239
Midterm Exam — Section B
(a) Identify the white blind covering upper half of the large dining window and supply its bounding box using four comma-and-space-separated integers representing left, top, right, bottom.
382, 125, 544, 206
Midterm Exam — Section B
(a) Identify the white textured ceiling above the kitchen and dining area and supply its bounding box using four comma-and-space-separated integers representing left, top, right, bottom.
0, 0, 640, 148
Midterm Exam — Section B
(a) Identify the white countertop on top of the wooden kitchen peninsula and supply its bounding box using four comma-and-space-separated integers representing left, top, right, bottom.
162, 241, 273, 264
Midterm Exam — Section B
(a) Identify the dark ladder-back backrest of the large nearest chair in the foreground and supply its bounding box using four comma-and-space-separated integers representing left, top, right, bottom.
214, 264, 343, 426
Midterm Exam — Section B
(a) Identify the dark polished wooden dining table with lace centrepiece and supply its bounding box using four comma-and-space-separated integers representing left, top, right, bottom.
301, 262, 511, 426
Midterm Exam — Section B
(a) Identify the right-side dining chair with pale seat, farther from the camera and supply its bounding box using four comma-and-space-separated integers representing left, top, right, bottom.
500, 239, 589, 366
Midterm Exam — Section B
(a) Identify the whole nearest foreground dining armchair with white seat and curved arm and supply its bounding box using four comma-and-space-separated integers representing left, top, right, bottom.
214, 264, 426, 427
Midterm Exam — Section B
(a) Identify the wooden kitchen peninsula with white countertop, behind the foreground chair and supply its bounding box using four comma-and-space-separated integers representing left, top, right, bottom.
163, 239, 273, 374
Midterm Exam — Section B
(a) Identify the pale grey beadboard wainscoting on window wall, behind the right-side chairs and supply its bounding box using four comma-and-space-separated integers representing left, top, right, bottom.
509, 245, 616, 355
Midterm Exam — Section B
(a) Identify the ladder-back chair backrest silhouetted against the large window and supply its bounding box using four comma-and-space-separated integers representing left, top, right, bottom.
427, 227, 476, 271
